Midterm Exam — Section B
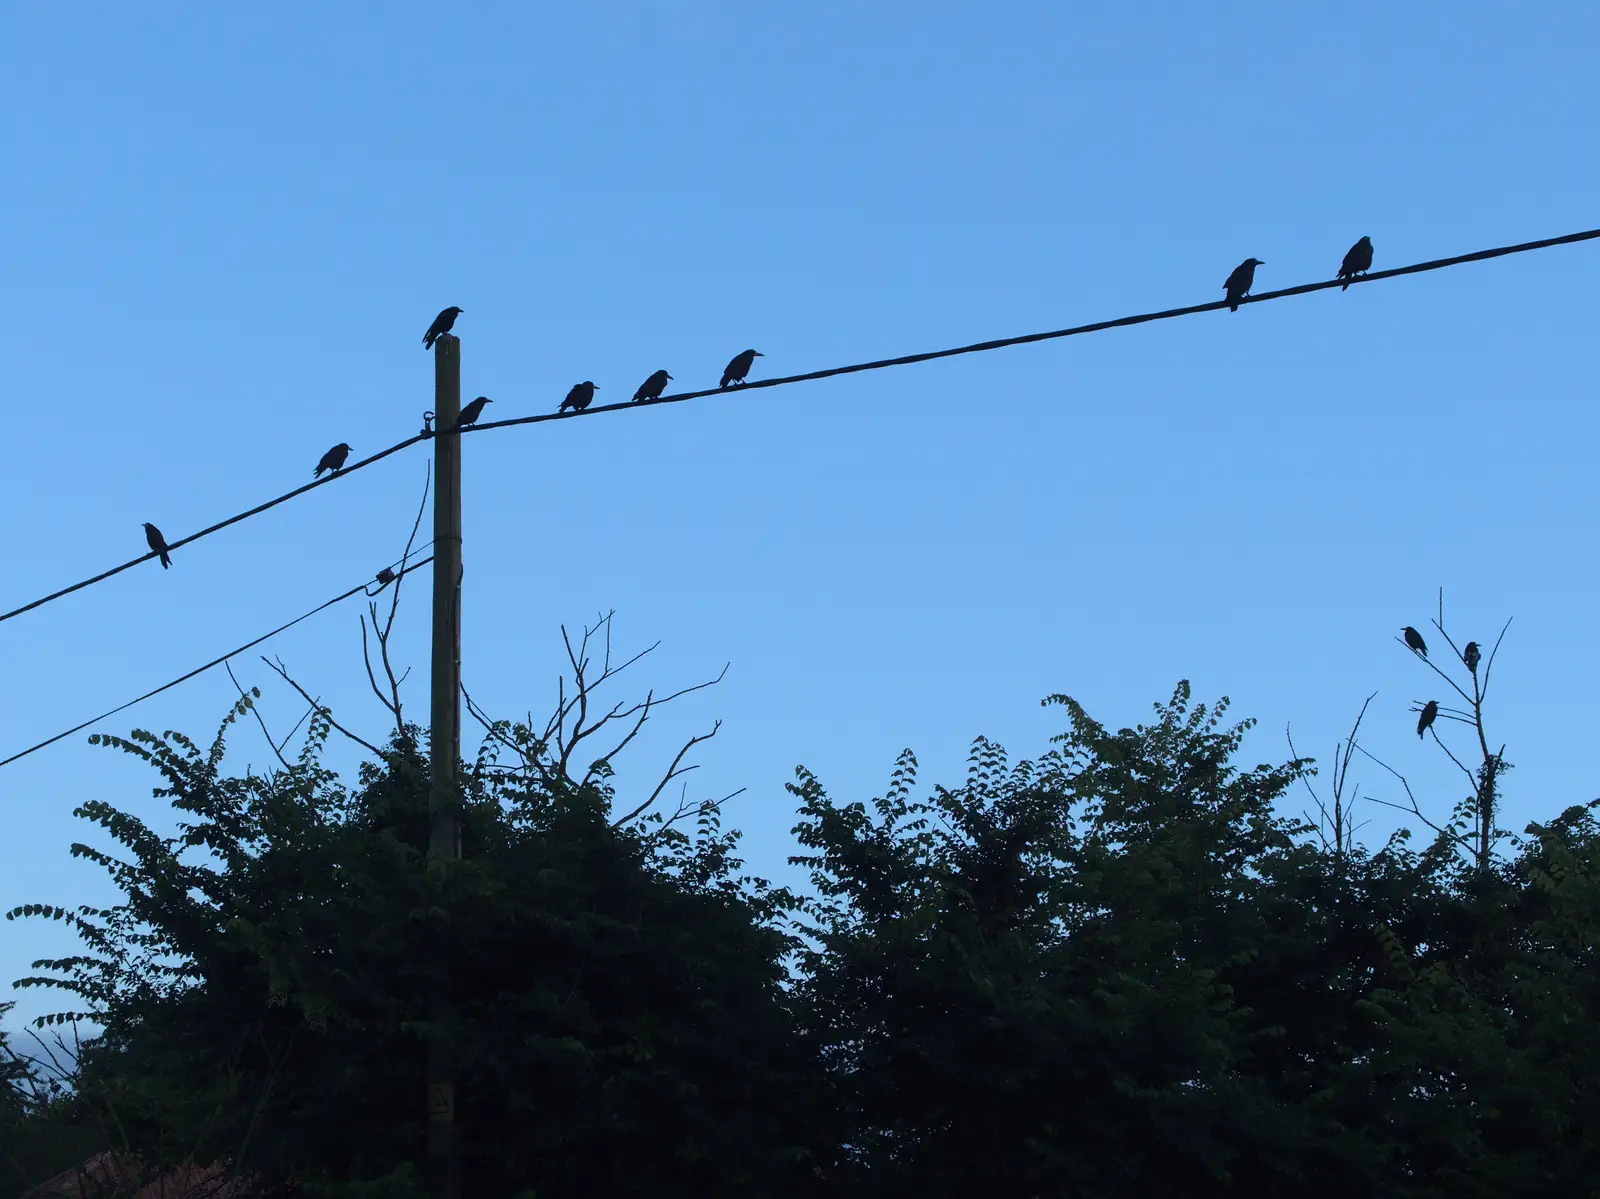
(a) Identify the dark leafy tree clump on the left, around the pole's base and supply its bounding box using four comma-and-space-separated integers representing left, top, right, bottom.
19, 700, 814, 1196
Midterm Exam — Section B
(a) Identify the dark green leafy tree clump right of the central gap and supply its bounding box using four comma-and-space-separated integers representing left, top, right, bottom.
792, 685, 1600, 1197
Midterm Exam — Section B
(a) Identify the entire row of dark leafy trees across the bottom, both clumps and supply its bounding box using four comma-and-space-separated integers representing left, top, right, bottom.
6, 685, 1600, 1199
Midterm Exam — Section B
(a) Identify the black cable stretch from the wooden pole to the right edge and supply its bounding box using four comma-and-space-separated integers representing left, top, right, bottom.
462, 229, 1600, 432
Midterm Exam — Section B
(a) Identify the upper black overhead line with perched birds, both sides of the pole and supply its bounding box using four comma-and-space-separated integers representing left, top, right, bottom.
0, 229, 1600, 637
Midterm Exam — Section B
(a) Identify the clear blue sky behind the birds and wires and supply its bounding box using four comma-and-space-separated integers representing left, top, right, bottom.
0, 0, 1600, 1015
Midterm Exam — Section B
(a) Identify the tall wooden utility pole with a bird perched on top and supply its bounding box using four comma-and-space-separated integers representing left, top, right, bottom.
427, 333, 461, 1199
